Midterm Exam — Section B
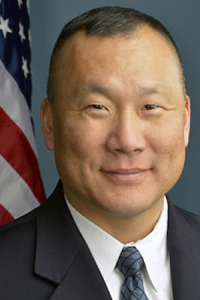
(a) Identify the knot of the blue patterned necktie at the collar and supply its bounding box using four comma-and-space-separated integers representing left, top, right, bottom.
116, 247, 144, 277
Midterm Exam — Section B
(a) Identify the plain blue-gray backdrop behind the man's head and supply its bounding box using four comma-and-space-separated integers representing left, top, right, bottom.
30, 0, 200, 214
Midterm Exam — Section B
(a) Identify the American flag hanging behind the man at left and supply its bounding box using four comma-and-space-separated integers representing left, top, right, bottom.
0, 0, 45, 225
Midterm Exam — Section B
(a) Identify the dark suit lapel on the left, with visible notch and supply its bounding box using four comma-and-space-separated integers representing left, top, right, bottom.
35, 183, 111, 300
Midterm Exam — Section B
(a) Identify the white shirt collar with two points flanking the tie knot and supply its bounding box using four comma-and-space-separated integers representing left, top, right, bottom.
65, 197, 168, 291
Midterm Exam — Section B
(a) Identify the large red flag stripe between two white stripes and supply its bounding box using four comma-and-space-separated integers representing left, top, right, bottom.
0, 107, 46, 203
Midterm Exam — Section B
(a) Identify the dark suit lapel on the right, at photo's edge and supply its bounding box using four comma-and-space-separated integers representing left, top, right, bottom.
168, 201, 200, 300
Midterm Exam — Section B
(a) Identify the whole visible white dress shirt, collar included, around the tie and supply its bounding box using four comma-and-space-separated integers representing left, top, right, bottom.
66, 198, 173, 300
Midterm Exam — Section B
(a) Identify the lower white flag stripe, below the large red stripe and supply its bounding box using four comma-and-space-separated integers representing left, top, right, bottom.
0, 155, 39, 219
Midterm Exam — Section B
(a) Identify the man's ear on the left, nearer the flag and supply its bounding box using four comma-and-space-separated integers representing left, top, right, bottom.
40, 98, 54, 150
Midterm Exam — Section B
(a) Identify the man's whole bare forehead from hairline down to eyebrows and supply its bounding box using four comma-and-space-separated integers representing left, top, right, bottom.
55, 26, 181, 98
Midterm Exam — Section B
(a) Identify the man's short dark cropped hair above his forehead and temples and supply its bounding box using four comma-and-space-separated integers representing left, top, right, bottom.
47, 6, 186, 103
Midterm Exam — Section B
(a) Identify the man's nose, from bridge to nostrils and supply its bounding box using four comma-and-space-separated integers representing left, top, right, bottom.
107, 112, 146, 154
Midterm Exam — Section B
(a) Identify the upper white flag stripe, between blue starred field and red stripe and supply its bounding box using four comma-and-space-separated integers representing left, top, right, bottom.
0, 60, 37, 156
